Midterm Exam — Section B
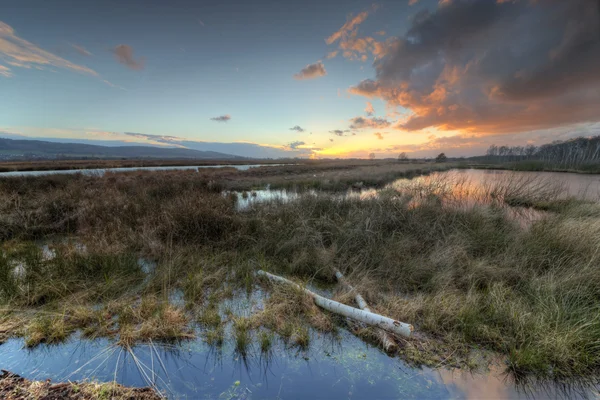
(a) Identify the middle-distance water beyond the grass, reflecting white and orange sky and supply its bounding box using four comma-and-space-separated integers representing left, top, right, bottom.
235, 169, 600, 216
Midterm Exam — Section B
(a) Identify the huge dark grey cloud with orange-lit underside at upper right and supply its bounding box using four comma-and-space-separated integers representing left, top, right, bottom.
349, 0, 600, 134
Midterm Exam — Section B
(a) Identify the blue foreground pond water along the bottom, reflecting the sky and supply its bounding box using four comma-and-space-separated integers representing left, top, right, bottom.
0, 324, 592, 399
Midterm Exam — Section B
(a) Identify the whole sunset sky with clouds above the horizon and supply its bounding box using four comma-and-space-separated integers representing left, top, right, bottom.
0, 0, 600, 158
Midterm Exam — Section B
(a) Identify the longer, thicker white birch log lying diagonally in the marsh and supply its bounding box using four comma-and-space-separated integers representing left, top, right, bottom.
256, 270, 413, 337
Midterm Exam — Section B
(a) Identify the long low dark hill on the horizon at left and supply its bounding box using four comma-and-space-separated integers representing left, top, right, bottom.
0, 138, 243, 160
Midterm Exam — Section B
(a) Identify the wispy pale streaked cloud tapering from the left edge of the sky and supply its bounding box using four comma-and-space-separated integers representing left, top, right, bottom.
0, 21, 98, 77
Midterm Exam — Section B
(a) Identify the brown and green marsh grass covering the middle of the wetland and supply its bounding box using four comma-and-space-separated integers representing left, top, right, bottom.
0, 167, 600, 379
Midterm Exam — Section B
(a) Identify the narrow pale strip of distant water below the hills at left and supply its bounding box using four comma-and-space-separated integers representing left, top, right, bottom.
0, 164, 289, 178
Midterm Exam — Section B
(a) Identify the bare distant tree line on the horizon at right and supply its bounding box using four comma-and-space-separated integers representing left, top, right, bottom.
486, 136, 600, 167
